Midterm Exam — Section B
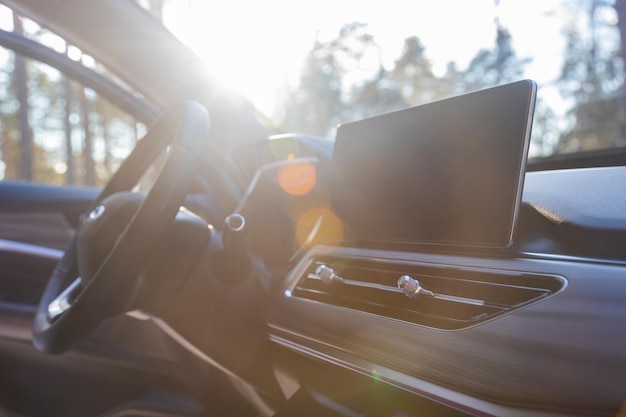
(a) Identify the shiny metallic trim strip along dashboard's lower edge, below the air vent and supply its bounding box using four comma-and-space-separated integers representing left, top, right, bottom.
269, 332, 564, 417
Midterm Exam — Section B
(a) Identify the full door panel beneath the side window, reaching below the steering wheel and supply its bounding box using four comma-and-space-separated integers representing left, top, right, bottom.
0, 182, 213, 416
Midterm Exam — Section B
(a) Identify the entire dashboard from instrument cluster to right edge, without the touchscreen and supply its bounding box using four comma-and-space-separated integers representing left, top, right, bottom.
212, 82, 626, 416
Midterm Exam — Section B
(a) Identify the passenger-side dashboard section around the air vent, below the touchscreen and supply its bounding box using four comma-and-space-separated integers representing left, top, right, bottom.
260, 167, 626, 416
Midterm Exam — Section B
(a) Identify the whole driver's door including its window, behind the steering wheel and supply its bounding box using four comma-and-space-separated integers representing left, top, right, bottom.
0, 8, 225, 417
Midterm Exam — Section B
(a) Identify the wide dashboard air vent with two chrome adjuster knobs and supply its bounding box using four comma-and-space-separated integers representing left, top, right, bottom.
289, 257, 565, 330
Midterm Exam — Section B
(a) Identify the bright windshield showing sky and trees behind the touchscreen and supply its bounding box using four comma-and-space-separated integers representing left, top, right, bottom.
158, 0, 626, 157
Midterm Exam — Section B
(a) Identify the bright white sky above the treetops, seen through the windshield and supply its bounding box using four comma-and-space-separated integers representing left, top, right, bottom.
164, 0, 563, 113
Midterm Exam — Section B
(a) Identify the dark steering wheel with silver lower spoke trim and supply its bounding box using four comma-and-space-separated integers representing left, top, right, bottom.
33, 102, 209, 353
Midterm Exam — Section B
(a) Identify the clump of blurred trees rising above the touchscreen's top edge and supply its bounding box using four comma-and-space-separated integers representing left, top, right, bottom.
283, 21, 532, 136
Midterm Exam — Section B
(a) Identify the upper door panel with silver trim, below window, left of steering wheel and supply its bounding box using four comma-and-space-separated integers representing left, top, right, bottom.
0, 182, 98, 340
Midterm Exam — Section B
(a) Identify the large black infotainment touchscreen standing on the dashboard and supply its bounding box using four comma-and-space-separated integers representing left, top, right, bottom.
332, 80, 536, 247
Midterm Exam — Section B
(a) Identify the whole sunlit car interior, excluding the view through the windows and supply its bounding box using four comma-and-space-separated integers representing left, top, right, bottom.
0, 0, 626, 417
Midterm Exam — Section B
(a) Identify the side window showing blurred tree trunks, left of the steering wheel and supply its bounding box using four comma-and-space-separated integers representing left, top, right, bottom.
0, 11, 146, 186
